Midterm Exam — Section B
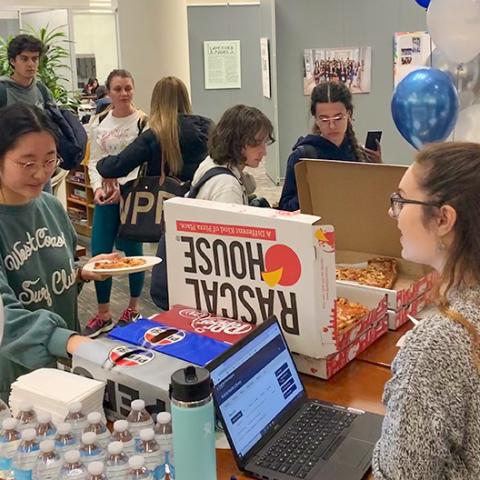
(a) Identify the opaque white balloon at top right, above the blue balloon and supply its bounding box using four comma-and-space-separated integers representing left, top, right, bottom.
427, 0, 480, 63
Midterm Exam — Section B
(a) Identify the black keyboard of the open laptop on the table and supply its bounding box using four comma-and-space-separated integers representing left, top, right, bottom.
256, 402, 357, 478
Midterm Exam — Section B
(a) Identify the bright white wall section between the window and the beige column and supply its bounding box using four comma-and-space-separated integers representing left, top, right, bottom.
73, 12, 118, 84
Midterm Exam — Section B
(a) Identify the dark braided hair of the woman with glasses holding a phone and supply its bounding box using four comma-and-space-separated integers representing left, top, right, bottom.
310, 82, 368, 162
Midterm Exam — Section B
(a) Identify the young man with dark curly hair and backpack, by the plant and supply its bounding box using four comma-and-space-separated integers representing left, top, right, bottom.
0, 34, 87, 176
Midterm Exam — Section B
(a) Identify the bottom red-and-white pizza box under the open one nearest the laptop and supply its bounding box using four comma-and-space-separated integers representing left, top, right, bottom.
293, 315, 388, 380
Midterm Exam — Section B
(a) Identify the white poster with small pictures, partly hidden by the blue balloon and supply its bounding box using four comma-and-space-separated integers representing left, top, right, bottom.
393, 32, 435, 87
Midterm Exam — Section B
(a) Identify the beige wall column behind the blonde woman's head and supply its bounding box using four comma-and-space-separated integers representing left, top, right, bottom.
118, 0, 190, 112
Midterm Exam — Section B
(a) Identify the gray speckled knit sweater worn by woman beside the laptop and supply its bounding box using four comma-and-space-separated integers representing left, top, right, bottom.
372, 288, 480, 480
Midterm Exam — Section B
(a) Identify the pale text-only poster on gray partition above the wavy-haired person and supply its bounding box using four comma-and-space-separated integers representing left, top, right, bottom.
203, 40, 242, 90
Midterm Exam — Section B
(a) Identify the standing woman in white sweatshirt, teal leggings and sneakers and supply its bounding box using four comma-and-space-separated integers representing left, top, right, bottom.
85, 70, 147, 338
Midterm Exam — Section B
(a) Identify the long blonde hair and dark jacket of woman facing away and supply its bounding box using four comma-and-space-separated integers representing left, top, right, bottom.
97, 77, 212, 181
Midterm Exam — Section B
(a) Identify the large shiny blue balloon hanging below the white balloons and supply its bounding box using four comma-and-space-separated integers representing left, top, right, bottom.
391, 68, 459, 149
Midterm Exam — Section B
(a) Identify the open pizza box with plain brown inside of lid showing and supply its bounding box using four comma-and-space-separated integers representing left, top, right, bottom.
295, 159, 433, 311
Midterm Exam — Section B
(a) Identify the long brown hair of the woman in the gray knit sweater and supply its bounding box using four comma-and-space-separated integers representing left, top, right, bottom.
416, 142, 480, 369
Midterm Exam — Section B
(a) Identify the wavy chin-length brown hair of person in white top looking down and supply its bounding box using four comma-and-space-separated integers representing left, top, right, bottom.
208, 105, 275, 167
